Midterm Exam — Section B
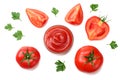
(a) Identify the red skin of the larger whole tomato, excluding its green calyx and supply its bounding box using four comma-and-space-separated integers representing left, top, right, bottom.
75, 46, 103, 73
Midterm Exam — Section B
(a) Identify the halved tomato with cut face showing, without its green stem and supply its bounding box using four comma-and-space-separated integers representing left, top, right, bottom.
85, 16, 110, 40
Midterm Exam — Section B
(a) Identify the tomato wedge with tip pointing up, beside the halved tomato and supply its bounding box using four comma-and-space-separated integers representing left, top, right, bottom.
65, 3, 83, 25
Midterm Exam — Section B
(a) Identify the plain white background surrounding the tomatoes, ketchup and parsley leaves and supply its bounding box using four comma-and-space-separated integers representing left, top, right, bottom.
0, 0, 120, 80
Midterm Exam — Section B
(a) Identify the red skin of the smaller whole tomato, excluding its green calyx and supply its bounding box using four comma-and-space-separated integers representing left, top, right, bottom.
16, 46, 40, 69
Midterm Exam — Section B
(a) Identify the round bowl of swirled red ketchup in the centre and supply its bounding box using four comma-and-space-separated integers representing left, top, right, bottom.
44, 25, 73, 54
